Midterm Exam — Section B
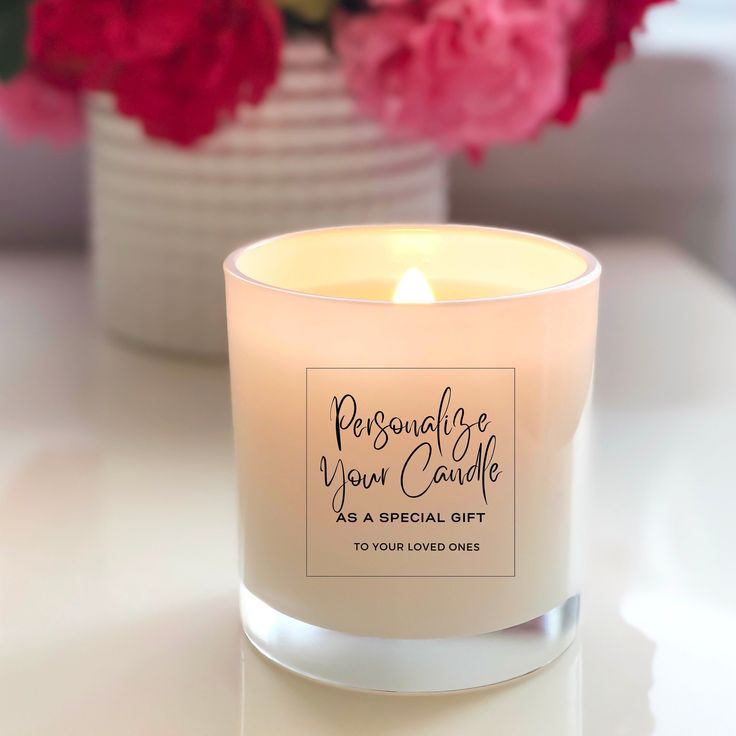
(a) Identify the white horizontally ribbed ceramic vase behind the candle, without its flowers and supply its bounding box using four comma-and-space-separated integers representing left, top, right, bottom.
89, 40, 447, 356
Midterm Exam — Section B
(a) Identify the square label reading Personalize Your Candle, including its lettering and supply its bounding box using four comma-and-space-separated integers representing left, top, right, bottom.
306, 368, 516, 577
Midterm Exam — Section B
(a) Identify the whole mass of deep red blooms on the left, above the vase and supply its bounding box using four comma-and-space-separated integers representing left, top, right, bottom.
29, 0, 283, 145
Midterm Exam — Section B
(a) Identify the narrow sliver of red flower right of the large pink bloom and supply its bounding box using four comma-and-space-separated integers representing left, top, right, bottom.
555, 0, 667, 123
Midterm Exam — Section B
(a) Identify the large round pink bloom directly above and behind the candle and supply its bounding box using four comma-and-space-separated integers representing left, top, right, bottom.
336, 0, 576, 155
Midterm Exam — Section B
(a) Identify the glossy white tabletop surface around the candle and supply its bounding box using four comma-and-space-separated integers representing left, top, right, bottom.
0, 243, 736, 736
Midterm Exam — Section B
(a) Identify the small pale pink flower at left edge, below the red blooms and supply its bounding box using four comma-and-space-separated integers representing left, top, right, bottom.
0, 69, 84, 146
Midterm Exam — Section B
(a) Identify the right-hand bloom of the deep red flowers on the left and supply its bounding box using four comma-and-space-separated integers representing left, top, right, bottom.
112, 0, 283, 145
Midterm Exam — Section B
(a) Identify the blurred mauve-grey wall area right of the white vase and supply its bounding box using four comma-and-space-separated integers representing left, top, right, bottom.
453, 49, 736, 282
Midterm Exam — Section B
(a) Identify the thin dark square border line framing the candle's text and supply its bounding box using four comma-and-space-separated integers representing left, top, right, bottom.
304, 366, 516, 578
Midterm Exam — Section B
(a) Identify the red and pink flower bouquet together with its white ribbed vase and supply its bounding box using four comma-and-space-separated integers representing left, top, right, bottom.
0, 0, 660, 353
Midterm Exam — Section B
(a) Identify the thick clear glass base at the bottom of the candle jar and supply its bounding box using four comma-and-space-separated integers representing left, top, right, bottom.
240, 585, 579, 693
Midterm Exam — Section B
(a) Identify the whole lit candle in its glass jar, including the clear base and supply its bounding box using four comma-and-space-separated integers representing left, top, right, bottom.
225, 225, 600, 692
